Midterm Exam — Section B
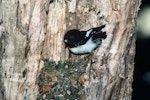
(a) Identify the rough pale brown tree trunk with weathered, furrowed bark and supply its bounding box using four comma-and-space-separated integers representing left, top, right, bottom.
0, 0, 141, 100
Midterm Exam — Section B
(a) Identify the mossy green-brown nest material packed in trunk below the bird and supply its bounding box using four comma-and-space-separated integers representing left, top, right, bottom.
36, 59, 88, 100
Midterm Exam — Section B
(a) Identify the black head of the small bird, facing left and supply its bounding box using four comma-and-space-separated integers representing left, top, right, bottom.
64, 29, 80, 47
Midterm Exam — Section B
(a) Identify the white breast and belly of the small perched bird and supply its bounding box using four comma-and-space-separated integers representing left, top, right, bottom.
69, 38, 100, 54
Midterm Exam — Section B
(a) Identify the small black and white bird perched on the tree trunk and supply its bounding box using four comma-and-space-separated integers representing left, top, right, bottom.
64, 25, 107, 55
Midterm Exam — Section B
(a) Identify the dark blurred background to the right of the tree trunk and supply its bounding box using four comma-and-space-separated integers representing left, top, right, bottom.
132, 0, 150, 100
